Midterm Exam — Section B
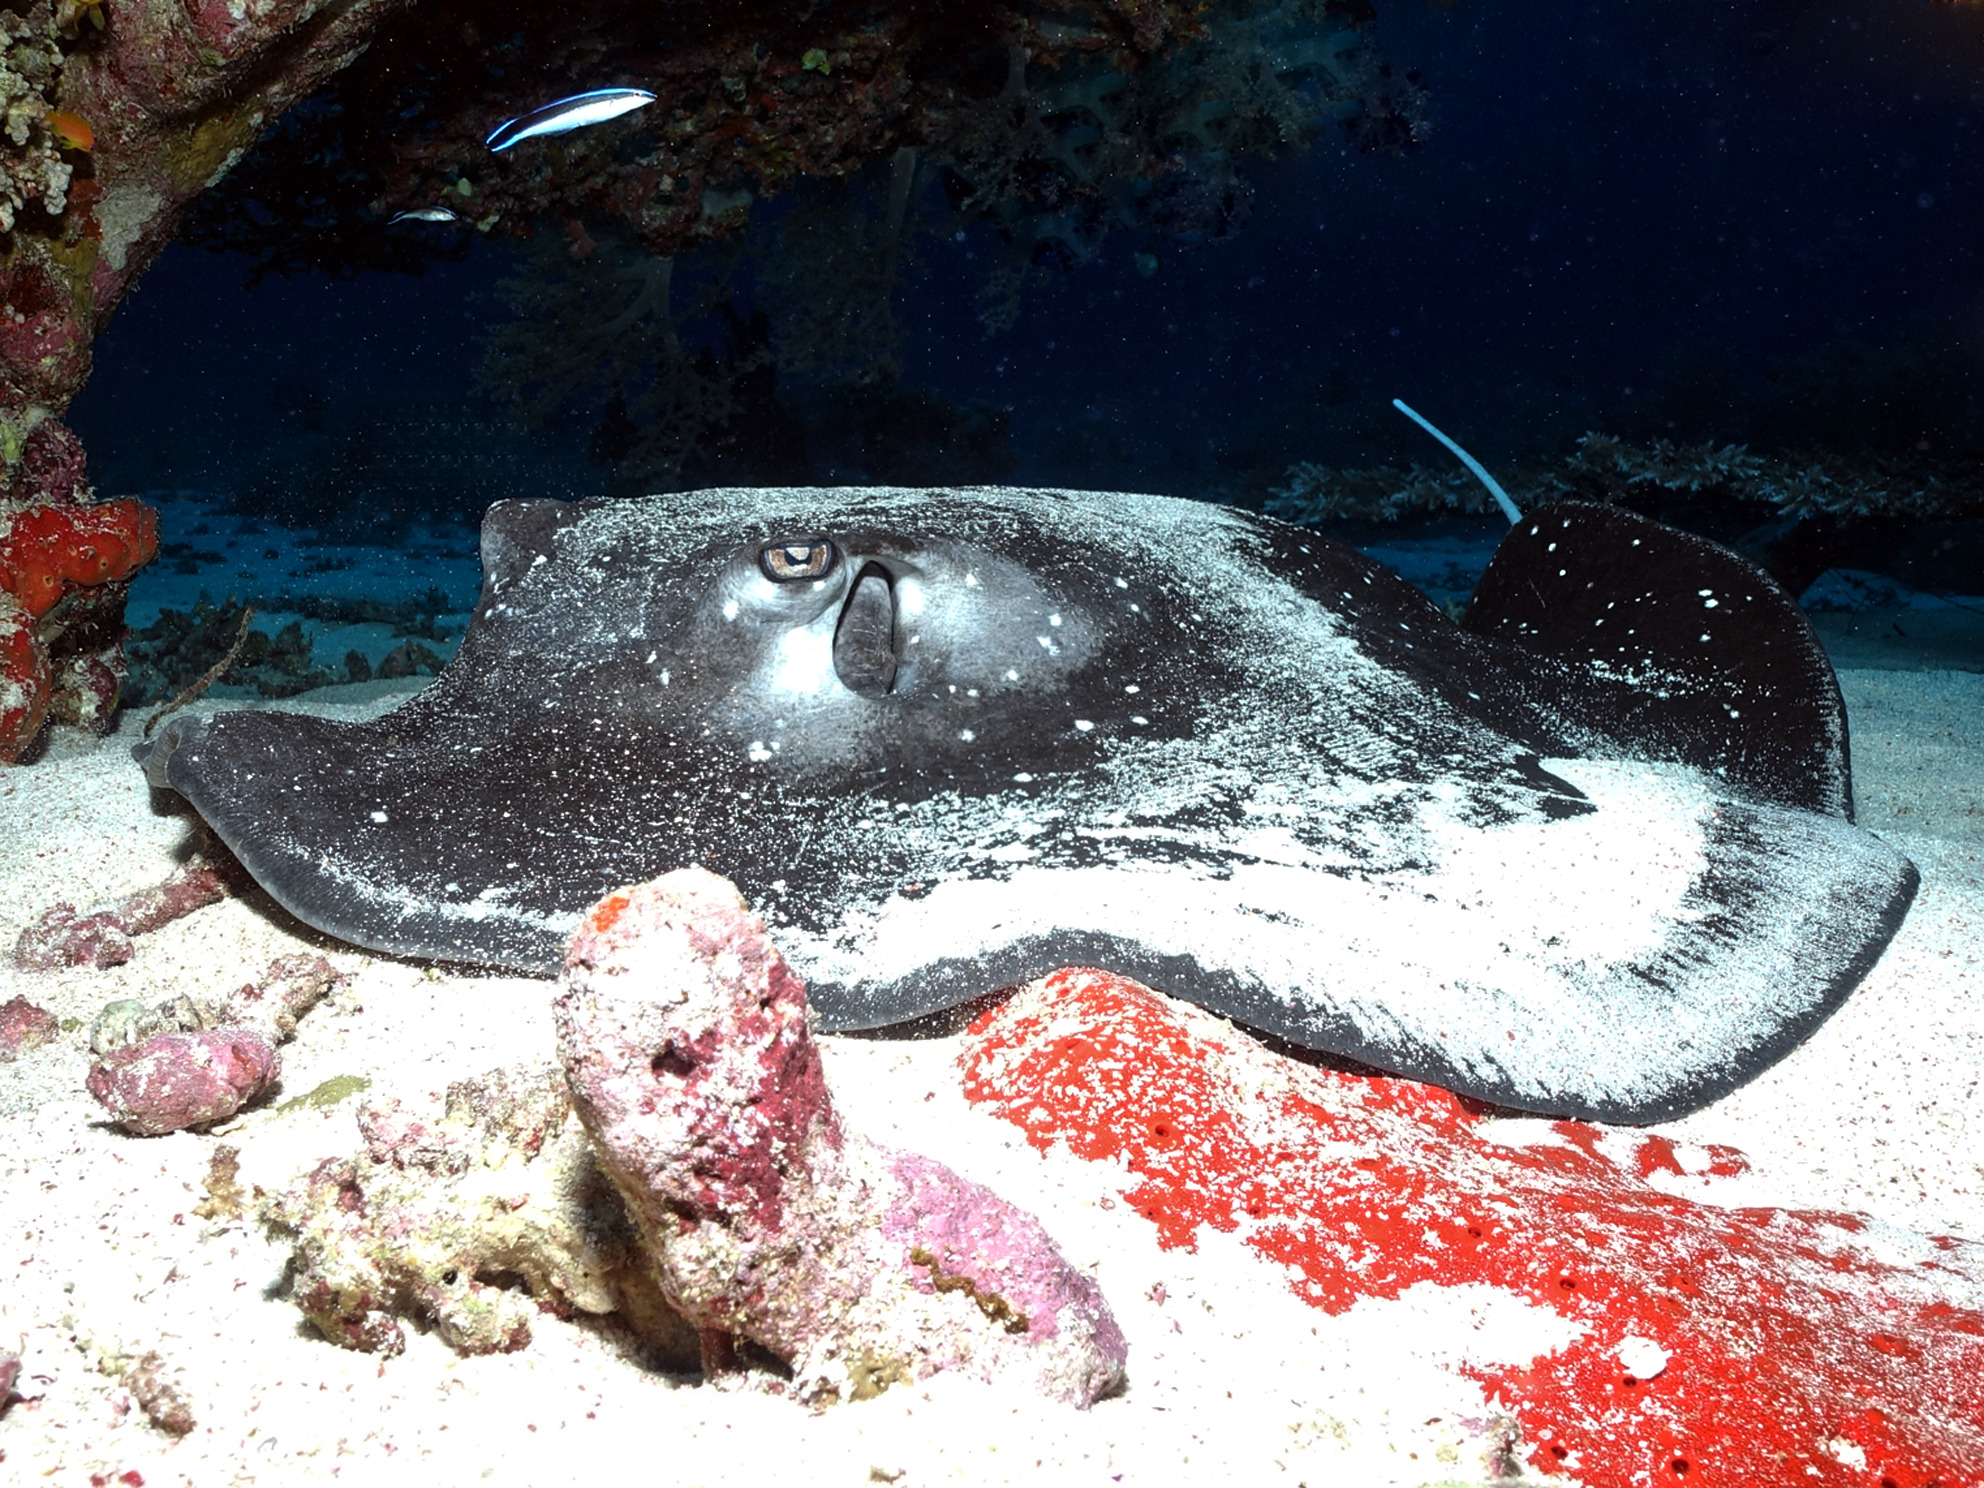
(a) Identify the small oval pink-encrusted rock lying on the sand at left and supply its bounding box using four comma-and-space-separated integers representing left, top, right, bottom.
89, 1028, 282, 1137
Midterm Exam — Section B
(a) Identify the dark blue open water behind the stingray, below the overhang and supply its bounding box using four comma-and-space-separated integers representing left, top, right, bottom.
73, 0, 1984, 547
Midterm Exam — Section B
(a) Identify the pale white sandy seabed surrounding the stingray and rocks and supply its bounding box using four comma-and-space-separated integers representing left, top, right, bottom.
0, 671, 1984, 1488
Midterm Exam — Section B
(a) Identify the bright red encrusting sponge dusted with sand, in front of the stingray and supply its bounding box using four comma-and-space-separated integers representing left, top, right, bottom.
962, 970, 1984, 1488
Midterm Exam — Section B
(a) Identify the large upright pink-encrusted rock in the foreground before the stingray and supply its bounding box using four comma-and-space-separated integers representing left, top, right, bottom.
554, 869, 1125, 1407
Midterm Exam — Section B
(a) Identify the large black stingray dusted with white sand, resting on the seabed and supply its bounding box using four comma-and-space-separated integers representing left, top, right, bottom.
139, 490, 1917, 1121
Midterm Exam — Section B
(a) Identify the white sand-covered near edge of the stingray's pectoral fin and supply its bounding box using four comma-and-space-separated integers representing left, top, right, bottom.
786, 760, 1919, 1123
